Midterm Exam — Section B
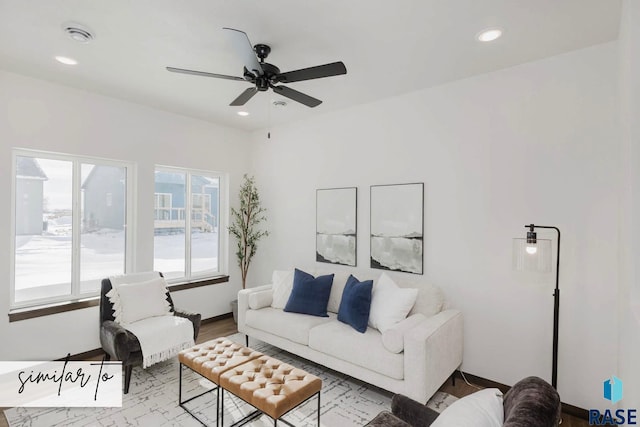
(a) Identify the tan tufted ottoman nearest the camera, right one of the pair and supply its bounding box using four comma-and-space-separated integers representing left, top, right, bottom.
220, 355, 322, 426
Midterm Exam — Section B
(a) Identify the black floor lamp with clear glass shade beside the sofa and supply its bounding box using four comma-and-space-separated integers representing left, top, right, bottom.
513, 224, 560, 389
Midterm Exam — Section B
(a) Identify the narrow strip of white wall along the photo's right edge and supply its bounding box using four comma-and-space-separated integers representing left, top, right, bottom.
618, 0, 640, 408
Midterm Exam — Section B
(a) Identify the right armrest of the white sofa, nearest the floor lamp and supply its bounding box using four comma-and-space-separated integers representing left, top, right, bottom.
404, 309, 463, 403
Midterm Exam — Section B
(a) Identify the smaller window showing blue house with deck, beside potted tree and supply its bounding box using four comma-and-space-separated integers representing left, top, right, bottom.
154, 167, 222, 281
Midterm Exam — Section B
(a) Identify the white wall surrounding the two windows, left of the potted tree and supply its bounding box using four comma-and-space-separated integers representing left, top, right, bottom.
0, 72, 250, 360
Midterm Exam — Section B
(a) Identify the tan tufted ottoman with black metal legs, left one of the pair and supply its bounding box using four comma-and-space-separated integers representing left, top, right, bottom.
178, 337, 262, 425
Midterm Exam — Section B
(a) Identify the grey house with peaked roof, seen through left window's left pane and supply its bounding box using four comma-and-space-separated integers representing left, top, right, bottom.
16, 156, 48, 235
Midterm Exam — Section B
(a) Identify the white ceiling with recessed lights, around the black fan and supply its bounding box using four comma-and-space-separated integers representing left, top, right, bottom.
0, 0, 620, 130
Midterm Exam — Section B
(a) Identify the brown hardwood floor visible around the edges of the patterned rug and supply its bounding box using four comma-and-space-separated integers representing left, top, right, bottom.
0, 318, 589, 427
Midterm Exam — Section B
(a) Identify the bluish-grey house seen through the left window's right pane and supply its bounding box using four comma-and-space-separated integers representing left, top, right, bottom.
82, 165, 126, 231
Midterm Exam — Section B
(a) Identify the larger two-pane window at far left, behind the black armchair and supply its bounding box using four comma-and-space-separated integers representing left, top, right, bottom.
11, 150, 132, 308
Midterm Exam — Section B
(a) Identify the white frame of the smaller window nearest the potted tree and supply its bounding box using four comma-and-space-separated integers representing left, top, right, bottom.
153, 165, 229, 283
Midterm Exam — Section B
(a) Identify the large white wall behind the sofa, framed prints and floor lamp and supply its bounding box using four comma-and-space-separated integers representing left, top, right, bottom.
250, 43, 621, 408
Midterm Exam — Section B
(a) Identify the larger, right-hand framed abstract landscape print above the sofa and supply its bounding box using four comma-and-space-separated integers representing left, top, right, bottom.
370, 183, 424, 274
